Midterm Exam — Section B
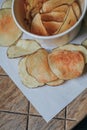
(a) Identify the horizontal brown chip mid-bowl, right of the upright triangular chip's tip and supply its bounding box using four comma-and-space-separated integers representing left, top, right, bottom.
41, 11, 66, 22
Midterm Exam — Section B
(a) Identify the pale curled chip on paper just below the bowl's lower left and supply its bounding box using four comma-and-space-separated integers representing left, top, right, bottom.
7, 39, 41, 58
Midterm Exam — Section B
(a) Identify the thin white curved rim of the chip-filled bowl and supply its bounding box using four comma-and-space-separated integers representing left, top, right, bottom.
12, 0, 87, 40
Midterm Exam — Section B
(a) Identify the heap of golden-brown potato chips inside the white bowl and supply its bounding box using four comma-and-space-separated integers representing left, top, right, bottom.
24, 0, 81, 36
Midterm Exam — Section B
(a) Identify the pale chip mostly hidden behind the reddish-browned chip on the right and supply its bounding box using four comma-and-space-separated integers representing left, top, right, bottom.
53, 44, 87, 63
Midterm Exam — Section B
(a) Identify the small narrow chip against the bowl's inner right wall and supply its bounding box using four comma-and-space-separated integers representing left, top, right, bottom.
72, 2, 81, 19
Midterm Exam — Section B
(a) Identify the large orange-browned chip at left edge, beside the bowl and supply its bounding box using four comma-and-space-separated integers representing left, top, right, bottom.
0, 9, 22, 46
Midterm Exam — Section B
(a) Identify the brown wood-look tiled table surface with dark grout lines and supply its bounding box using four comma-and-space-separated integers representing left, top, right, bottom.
0, 67, 87, 130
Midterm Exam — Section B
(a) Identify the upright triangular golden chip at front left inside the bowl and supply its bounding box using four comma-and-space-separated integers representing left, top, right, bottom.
31, 13, 48, 36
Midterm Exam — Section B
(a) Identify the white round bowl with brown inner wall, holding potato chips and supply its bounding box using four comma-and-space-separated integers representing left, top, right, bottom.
12, 0, 87, 49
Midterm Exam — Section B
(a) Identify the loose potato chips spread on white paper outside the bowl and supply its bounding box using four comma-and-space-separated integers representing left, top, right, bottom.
0, 0, 87, 88
